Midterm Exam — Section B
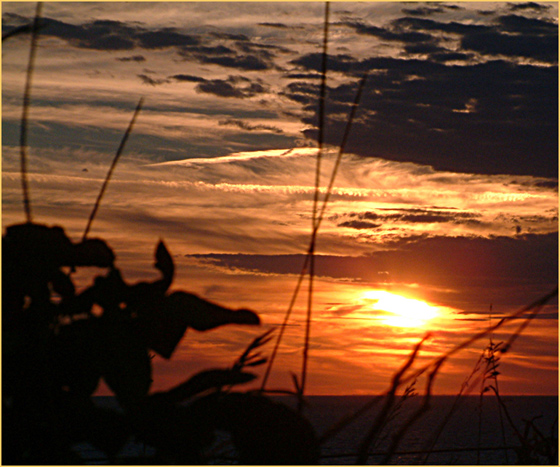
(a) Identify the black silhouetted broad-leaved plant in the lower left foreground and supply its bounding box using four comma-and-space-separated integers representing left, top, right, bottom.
2, 223, 318, 464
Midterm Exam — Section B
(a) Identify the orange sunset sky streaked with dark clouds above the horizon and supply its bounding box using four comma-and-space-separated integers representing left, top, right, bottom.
2, 2, 558, 394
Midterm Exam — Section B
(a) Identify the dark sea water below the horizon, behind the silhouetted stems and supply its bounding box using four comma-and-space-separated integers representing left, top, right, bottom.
86, 396, 558, 465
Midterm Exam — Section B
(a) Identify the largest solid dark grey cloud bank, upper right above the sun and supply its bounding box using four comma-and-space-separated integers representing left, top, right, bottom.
283, 54, 558, 178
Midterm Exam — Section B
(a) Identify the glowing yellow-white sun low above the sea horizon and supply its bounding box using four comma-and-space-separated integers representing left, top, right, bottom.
362, 290, 439, 328
